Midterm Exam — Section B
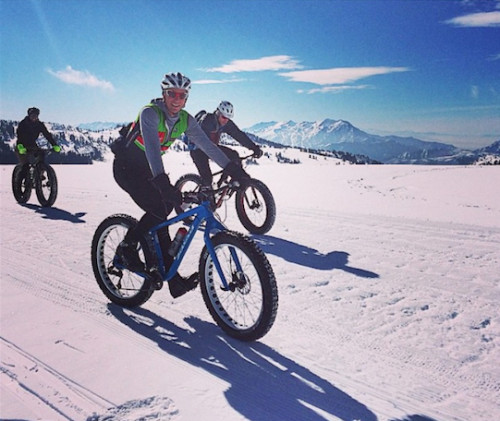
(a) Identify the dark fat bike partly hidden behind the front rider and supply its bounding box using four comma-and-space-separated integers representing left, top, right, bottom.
175, 155, 276, 235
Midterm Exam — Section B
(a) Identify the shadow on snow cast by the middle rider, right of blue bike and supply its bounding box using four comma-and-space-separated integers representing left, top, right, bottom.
252, 235, 380, 278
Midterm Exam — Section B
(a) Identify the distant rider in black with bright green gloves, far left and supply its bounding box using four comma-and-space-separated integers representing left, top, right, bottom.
16, 107, 61, 164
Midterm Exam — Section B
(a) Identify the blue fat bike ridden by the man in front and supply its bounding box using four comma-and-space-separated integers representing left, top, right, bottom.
91, 189, 278, 341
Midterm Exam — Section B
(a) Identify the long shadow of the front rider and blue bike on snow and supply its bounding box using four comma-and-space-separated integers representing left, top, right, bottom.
108, 303, 377, 421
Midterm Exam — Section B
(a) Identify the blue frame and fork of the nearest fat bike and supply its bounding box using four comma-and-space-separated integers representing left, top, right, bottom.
149, 201, 242, 290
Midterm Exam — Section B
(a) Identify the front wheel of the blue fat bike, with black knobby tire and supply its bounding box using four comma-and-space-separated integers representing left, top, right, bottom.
199, 231, 278, 341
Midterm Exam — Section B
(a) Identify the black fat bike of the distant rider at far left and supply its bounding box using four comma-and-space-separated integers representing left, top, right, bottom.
12, 149, 57, 207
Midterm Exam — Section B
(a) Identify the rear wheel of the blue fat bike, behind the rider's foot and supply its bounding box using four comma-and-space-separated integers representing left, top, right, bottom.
91, 215, 154, 308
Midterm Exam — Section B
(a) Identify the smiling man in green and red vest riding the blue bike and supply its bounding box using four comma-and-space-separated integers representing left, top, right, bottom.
113, 73, 249, 298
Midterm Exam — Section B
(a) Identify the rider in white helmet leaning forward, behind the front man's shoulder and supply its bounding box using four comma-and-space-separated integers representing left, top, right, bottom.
188, 101, 262, 186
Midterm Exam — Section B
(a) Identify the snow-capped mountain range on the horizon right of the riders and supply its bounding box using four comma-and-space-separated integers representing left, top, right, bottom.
245, 119, 498, 164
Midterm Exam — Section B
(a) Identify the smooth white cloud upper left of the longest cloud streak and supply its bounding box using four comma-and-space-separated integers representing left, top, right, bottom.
205, 55, 303, 73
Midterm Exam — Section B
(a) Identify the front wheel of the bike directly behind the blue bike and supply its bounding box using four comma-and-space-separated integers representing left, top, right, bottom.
236, 178, 276, 234
